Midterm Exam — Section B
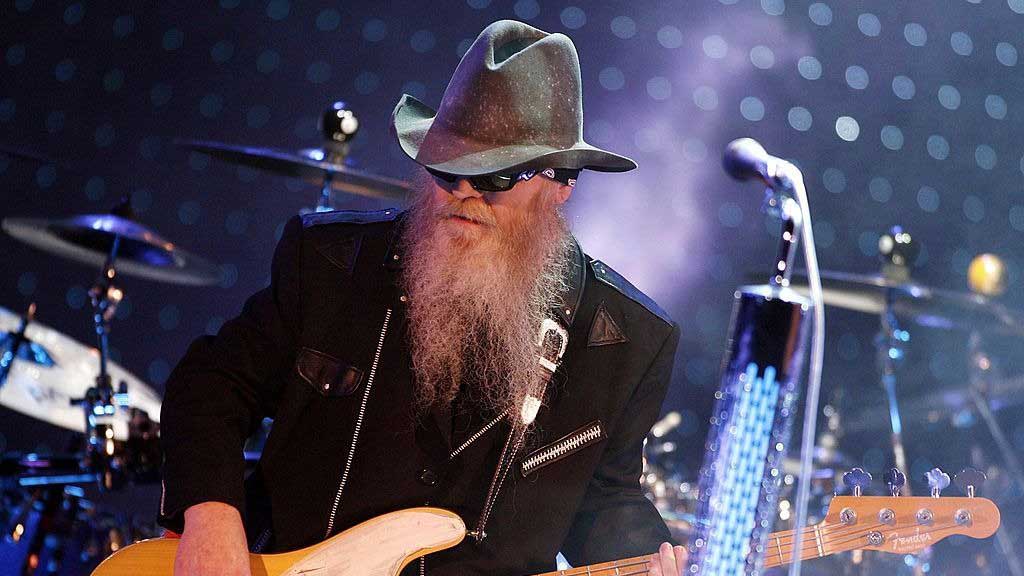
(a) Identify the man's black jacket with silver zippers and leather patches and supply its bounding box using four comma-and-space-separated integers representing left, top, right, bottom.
160, 210, 679, 575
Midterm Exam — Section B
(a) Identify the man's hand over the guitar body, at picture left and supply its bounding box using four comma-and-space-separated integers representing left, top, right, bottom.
174, 502, 251, 576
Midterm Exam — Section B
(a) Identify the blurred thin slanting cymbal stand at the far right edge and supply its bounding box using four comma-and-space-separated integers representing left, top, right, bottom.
968, 330, 1024, 576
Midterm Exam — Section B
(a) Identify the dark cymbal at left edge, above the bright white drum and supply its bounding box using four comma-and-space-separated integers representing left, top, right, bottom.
2, 214, 220, 286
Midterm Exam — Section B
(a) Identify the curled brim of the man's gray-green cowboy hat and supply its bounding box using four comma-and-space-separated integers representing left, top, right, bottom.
391, 94, 637, 176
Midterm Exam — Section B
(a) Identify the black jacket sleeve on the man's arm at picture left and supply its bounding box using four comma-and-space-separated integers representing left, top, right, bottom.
159, 216, 302, 533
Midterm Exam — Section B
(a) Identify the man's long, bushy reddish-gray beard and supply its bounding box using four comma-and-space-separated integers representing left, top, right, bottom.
404, 172, 575, 415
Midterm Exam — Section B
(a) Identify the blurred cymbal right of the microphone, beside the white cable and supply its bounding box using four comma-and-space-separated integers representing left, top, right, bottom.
791, 271, 1024, 335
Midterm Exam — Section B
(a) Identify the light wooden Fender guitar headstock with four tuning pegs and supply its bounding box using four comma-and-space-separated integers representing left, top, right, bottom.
820, 496, 999, 553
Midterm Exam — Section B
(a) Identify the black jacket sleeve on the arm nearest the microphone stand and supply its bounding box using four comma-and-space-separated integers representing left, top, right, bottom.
561, 324, 679, 566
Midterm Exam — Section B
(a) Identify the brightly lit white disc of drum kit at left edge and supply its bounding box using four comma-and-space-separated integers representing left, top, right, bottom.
0, 307, 160, 440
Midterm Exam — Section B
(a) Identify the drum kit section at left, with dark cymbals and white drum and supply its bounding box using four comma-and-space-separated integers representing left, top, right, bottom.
0, 102, 409, 575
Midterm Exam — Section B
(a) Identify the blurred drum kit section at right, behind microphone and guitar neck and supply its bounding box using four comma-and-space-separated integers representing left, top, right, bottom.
641, 227, 1024, 576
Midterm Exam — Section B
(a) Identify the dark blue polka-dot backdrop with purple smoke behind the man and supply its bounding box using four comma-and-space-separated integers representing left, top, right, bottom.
0, 0, 1024, 561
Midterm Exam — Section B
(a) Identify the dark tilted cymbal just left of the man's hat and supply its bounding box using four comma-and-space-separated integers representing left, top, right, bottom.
177, 140, 410, 201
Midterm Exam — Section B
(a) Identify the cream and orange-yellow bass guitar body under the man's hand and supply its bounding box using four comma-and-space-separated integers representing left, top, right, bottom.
92, 507, 466, 576
